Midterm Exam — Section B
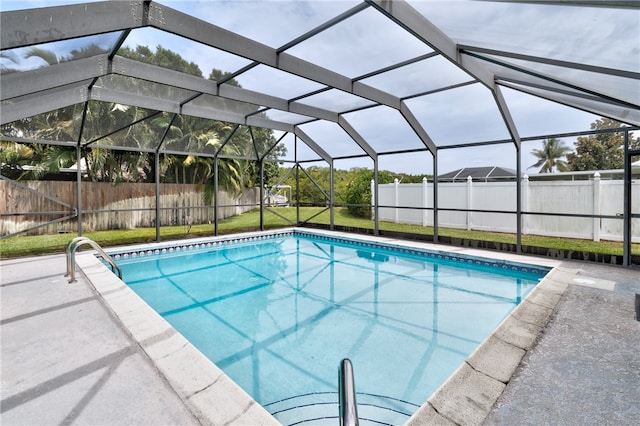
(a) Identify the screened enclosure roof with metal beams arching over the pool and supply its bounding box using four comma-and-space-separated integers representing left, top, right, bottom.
0, 0, 640, 162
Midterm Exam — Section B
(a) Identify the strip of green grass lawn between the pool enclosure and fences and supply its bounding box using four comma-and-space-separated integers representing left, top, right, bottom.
0, 207, 640, 259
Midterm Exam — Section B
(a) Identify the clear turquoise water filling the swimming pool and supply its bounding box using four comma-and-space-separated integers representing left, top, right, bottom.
118, 233, 546, 424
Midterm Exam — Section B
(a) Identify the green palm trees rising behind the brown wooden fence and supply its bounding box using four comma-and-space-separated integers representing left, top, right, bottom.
2, 41, 286, 201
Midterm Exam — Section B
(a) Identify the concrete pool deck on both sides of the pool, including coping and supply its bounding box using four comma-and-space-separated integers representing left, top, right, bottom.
0, 231, 640, 425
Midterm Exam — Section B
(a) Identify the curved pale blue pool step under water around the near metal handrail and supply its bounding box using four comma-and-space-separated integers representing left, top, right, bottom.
265, 392, 419, 426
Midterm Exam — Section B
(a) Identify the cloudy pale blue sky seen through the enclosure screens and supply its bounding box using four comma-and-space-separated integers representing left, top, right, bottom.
0, 0, 640, 174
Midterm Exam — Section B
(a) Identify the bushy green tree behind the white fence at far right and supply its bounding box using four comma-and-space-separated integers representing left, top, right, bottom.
567, 118, 640, 171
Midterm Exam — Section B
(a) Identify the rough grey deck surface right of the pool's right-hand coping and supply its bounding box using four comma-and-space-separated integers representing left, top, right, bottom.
485, 262, 640, 426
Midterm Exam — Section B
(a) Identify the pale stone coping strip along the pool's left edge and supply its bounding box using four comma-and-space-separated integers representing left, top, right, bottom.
76, 253, 280, 425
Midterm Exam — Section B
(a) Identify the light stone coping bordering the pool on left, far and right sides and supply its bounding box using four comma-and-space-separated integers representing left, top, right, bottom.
76, 228, 577, 425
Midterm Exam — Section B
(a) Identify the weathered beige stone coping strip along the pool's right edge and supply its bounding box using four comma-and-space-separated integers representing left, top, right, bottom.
406, 266, 577, 425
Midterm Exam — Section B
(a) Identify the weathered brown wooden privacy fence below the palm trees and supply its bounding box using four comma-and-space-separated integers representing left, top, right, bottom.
0, 180, 260, 236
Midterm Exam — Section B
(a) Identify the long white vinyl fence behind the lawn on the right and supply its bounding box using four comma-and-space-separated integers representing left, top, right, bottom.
371, 173, 640, 242
